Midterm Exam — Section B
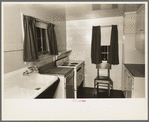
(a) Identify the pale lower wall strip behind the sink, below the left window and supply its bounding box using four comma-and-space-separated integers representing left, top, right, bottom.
4, 50, 55, 74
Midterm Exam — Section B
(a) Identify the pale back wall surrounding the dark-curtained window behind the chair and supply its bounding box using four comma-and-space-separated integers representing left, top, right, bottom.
66, 17, 123, 89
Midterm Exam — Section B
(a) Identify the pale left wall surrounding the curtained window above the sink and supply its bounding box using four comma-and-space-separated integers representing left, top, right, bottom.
2, 4, 66, 73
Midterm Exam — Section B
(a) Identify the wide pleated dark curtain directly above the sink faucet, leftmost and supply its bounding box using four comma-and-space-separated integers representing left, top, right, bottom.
23, 15, 38, 62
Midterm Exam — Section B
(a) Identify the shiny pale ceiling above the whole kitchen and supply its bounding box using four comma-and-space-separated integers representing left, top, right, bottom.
7, 2, 143, 21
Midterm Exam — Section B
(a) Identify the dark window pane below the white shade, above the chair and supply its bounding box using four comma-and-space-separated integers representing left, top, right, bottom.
101, 46, 110, 61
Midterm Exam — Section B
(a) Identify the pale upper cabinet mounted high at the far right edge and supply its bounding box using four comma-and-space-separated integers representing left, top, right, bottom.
135, 5, 145, 52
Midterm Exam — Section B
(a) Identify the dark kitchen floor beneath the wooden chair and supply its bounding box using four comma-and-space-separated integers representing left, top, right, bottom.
78, 87, 125, 98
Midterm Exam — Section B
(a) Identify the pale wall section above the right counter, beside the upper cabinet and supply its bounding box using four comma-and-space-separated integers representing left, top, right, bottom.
124, 12, 145, 64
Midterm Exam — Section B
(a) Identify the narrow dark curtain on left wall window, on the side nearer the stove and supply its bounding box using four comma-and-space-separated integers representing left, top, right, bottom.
47, 24, 58, 55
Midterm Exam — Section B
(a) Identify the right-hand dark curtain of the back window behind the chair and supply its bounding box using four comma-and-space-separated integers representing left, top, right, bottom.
108, 25, 119, 65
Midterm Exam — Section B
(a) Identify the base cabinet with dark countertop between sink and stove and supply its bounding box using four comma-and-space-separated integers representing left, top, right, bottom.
38, 62, 74, 99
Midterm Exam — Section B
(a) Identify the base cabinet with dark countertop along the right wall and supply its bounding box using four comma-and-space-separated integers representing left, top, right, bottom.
122, 64, 145, 98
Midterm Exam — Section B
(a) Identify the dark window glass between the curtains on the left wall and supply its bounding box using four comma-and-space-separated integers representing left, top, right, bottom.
36, 27, 49, 54
